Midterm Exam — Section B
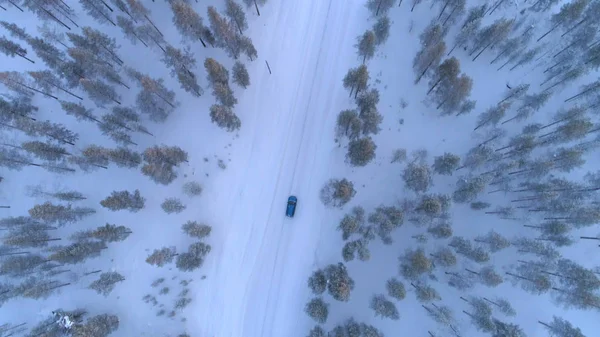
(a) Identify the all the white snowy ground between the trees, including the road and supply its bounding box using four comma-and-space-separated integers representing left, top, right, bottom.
0, 0, 597, 337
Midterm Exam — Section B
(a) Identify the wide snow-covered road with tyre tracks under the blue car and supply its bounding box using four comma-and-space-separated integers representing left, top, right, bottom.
189, 0, 362, 337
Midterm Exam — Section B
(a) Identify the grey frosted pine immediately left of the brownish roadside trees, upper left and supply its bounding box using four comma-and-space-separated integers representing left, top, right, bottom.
162, 46, 204, 96
